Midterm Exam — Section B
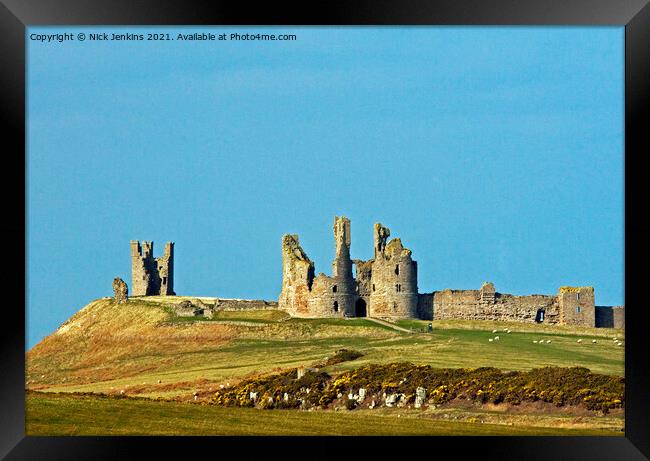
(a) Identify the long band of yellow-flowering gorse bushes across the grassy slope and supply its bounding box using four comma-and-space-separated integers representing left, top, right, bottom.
213, 363, 625, 413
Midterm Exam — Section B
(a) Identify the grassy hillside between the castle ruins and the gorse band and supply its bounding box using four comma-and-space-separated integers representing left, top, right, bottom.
27, 298, 624, 397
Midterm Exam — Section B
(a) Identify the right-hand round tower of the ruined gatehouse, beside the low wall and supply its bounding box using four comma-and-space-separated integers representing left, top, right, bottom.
368, 223, 418, 319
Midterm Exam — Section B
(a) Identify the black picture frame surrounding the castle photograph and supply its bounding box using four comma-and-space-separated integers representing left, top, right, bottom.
0, 0, 650, 461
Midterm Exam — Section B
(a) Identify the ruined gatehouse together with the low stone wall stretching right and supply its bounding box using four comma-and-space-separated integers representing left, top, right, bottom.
278, 216, 624, 328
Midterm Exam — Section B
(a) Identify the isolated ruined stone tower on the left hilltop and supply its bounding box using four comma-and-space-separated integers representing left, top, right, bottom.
131, 240, 175, 296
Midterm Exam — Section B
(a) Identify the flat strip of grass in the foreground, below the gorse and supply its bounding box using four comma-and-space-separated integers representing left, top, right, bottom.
26, 394, 622, 436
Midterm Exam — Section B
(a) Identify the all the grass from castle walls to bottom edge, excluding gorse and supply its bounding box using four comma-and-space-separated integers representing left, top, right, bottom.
27, 298, 624, 435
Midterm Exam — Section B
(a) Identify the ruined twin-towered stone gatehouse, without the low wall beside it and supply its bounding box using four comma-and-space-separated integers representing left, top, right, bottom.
278, 217, 418, 319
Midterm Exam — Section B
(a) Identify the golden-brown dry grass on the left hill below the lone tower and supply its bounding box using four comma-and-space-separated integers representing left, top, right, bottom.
27, 299, 236, 386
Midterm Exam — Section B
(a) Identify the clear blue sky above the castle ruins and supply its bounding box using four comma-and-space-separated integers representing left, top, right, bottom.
27, 27, 624, 347
